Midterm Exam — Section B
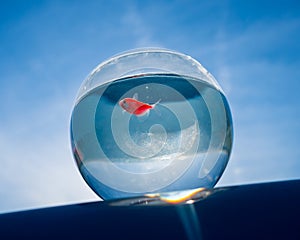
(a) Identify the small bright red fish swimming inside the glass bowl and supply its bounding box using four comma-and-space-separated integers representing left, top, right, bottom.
119, 94, 160, 116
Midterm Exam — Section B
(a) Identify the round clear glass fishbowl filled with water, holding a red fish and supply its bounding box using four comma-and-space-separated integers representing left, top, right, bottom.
70, 48, 233, 200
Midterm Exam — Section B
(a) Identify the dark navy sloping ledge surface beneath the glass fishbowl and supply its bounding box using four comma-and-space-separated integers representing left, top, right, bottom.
0, 180, 300, 239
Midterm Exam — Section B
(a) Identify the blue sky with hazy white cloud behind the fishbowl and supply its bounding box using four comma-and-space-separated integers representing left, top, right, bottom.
0, 0, 300, 213
